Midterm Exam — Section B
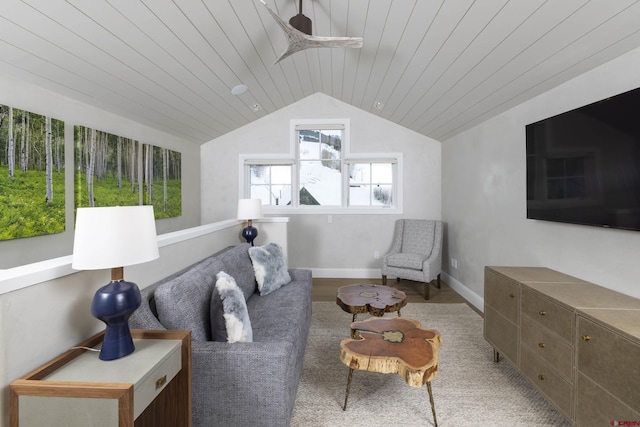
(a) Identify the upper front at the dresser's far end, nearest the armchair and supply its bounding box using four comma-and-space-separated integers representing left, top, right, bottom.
484, 268, 520, 325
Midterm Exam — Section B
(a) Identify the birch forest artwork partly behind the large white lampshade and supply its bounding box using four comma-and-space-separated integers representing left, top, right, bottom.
74, 126, 182, 219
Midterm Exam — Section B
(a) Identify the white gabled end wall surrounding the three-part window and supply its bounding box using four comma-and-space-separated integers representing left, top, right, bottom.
201, 93, 441, 277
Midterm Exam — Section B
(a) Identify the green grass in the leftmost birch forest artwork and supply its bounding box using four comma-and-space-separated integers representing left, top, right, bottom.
0, 166, 65, 240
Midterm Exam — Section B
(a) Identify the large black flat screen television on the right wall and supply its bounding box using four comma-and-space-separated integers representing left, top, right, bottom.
526, 88, 640, 231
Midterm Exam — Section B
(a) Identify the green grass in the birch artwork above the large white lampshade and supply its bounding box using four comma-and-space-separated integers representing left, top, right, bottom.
75, 173, 182, 219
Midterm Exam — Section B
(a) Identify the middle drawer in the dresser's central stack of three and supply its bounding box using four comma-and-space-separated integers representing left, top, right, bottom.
520, 318, 573, 382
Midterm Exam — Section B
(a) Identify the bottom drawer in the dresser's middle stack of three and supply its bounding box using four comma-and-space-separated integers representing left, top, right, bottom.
520, 349, 573, 419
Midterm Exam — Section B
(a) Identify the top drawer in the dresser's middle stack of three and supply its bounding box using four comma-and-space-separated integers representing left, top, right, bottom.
522, 287, 573, 343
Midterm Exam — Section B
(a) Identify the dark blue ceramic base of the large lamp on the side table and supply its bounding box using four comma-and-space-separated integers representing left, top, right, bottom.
91, 280, 141, 360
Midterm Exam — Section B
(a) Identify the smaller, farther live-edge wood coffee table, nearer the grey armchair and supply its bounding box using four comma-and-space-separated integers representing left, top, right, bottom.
336, 284, 407, 322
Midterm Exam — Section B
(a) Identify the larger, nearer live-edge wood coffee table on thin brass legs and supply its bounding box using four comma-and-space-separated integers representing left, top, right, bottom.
340, 317, 442, 427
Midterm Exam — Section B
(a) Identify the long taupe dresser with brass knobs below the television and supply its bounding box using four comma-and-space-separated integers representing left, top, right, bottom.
484, 266, 640, 427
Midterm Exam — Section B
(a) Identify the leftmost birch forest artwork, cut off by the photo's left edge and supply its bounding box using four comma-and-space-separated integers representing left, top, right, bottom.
0, 105, 65, 240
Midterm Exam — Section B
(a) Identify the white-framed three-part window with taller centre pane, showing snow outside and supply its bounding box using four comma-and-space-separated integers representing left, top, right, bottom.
240, 119, 402, 213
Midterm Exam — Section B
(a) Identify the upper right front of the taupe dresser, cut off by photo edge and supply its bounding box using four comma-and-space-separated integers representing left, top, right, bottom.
576, 317, 640, 412
